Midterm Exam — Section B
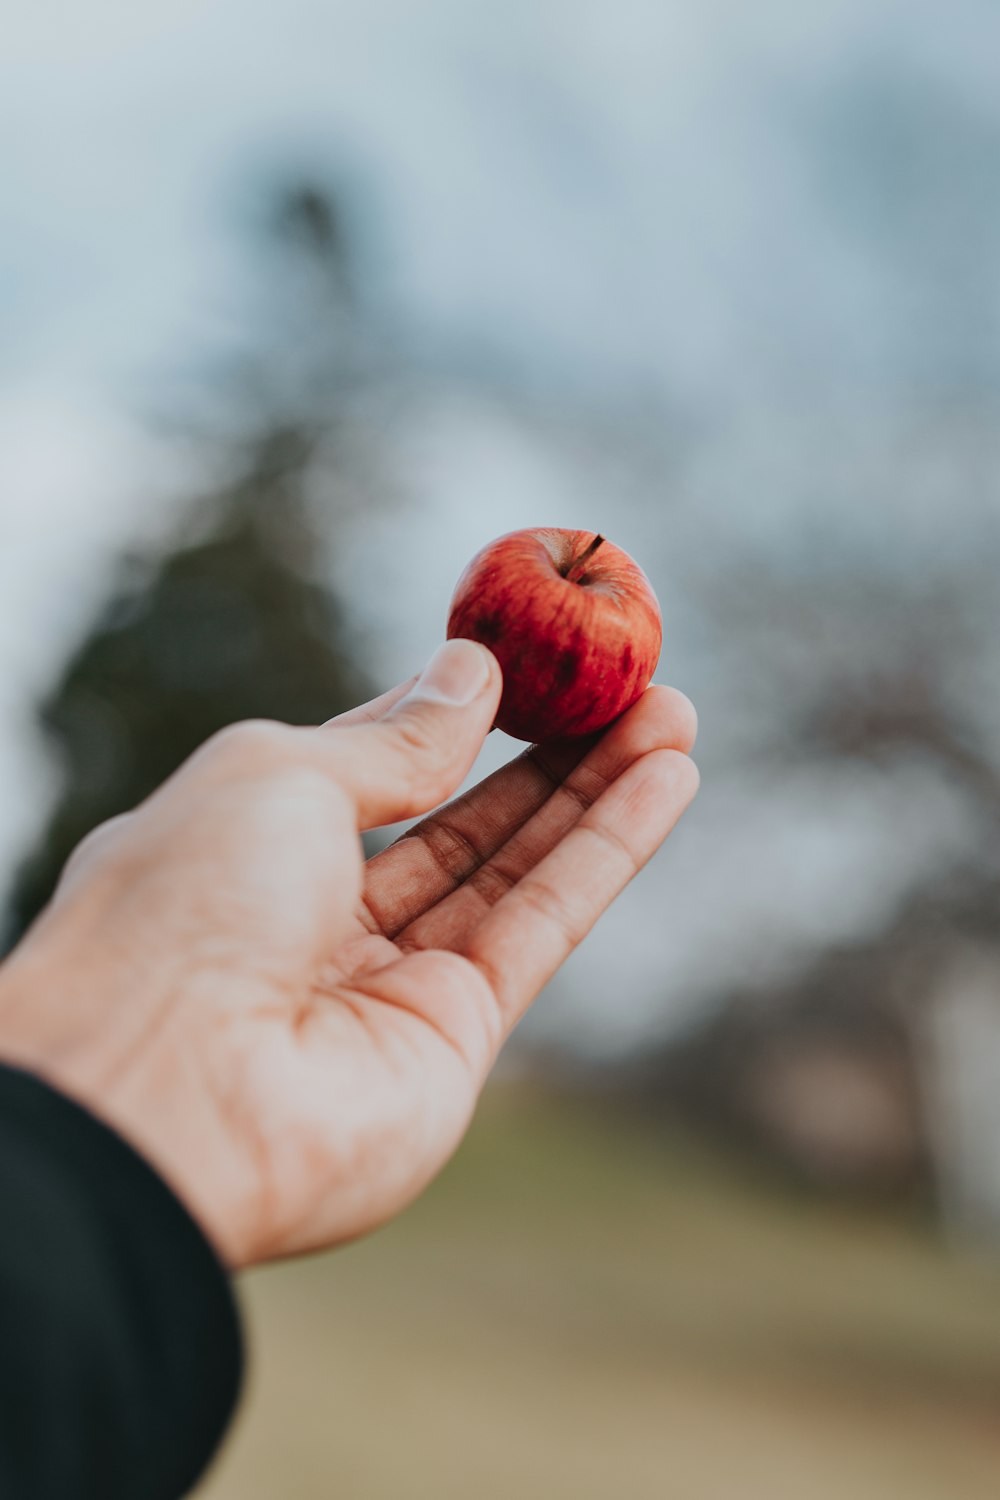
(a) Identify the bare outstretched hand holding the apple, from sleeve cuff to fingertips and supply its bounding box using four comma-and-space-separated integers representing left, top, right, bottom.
0, 641, 697, 1268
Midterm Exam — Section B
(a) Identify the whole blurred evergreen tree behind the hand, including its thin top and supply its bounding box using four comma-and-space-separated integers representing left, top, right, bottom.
6, 185, 379, 945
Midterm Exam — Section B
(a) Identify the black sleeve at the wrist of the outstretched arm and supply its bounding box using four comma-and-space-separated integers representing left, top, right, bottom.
0, 1067, 243, 1500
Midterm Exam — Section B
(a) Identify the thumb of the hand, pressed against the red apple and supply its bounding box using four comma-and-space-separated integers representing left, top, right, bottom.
319, 641, 502, 828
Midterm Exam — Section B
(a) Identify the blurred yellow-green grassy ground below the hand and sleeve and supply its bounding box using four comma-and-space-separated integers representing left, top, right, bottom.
198, 1085, 1000, 1500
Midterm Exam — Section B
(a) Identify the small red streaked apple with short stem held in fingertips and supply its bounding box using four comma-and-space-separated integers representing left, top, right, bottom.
448, 527, 663, 741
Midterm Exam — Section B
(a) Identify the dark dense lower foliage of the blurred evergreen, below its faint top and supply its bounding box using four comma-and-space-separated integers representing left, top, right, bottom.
9, 431, 367, 938
